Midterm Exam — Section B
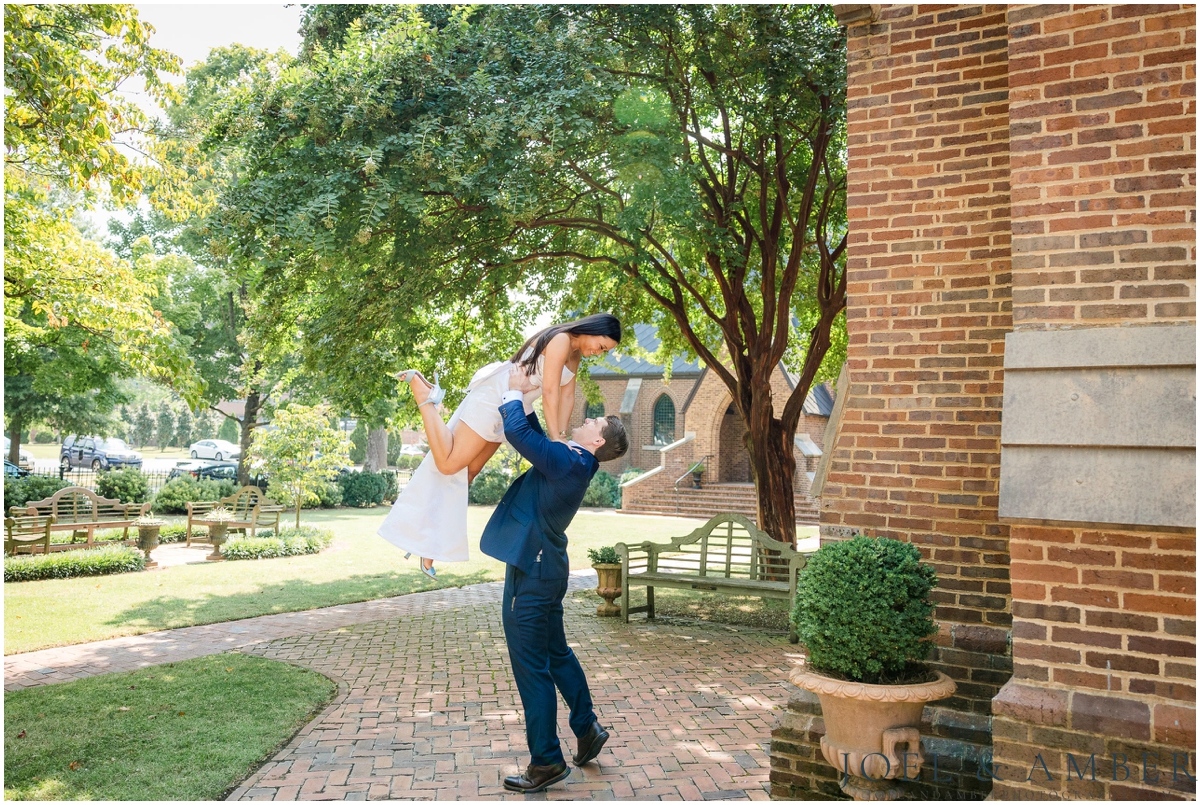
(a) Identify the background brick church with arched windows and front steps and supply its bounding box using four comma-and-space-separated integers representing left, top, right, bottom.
571, 324, 833, 525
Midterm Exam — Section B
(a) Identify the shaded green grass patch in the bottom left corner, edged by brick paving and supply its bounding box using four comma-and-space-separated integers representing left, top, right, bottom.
4, 654, 337, 800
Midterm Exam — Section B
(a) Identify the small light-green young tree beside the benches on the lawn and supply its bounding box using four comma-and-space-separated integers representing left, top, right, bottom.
250, 405, 350, 528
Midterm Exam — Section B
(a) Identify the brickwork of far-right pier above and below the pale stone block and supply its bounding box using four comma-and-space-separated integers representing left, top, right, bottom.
992, 5, 1196, 799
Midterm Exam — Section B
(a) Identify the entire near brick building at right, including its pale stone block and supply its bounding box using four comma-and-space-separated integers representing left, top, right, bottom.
772, 5, 1196, 799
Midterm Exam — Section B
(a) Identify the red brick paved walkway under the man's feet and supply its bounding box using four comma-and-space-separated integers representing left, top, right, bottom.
5, 572, 794, 800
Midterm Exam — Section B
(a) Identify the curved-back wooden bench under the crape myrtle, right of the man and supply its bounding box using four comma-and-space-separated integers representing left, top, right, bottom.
617, 515, 804, 643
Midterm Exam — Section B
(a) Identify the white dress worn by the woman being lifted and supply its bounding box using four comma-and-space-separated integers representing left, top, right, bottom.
376, 353, 575, 561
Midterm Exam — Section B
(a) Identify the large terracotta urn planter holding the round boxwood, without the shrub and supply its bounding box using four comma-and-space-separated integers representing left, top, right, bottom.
791, 669, 958, 800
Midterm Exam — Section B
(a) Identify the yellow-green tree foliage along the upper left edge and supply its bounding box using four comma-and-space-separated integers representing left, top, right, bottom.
4, 5, 200, 465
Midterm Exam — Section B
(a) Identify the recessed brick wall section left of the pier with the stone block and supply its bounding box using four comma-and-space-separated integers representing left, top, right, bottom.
821, 6, 1012, 715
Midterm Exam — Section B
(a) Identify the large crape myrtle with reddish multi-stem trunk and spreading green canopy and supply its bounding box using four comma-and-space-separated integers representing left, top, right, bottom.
222, 5, 846, 543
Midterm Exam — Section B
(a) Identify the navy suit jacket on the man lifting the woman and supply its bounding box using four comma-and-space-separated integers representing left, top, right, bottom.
479, 400, 600, 578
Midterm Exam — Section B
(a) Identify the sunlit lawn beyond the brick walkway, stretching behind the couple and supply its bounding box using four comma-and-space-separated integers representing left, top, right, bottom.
4, 506, 701, 654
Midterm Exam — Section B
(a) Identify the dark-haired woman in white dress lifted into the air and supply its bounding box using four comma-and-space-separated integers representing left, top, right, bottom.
378, 313, 620, 577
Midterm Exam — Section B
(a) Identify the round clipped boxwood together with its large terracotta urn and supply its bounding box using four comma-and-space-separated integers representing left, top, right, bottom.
791, 536, 955, 800
